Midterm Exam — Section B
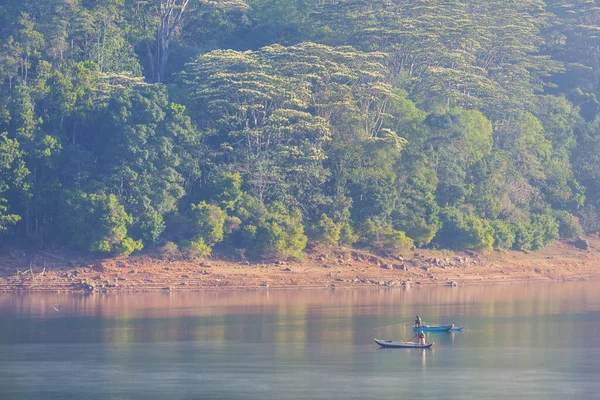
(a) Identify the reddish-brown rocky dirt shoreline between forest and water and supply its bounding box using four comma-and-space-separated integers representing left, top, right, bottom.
0, 236, 600, 293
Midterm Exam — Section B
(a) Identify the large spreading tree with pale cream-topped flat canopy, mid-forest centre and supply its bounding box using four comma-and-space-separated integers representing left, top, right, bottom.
184, 43, 402, 219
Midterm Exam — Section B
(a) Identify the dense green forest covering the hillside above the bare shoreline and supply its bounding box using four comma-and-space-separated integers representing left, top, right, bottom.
0, 0, 600, 259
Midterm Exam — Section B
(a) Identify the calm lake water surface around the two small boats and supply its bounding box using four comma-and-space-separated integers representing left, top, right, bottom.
0, 282, 600, 400
